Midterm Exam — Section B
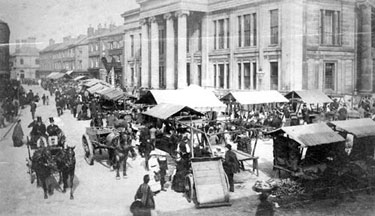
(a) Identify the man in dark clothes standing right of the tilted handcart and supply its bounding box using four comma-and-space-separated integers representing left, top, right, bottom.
223, 144, 240, 192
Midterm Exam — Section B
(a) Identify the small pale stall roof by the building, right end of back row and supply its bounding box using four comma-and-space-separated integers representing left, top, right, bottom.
285, 90, 333, 104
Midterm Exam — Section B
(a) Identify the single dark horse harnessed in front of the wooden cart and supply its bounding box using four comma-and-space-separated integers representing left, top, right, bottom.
112, 132, 135, 179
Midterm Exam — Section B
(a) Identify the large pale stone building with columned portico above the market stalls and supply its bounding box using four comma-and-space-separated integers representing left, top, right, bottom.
122, 0, 375, 93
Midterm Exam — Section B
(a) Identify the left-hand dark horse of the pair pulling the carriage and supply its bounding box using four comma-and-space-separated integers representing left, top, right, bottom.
31, 148, 57, 199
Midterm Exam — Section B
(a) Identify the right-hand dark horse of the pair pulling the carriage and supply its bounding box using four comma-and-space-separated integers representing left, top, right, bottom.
55, 147, 76, 199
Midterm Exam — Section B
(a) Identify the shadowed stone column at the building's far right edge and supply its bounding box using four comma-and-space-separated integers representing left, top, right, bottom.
358, 3, 373, 92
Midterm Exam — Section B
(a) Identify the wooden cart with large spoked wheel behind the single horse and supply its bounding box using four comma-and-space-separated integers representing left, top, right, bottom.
82, 127, 116, 165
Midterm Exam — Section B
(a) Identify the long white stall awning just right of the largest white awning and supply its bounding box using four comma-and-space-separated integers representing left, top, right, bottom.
221, 91, 289, 105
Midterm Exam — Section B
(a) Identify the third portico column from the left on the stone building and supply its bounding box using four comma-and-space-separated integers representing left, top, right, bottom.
164, 13, 176, 89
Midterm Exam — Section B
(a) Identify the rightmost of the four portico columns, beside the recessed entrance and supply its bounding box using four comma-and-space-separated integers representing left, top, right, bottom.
176, 11, 189, 88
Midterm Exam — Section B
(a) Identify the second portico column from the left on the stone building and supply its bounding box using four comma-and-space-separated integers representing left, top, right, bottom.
150, 17, 159, 89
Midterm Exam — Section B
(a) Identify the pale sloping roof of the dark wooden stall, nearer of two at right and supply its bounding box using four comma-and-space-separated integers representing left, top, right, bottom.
272, 123, 345, 147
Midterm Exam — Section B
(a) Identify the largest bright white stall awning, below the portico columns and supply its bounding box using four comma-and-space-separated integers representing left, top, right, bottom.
137, 85, 226, 112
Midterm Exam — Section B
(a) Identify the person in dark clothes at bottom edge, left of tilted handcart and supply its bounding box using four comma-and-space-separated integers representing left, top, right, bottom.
131, 175, 155, 216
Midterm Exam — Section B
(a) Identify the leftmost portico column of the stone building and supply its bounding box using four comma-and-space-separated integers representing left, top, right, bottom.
141, 19, 149, 87
